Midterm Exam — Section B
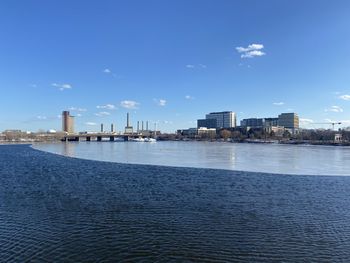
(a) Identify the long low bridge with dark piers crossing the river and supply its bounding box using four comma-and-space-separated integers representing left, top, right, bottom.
61, 132, 147, 142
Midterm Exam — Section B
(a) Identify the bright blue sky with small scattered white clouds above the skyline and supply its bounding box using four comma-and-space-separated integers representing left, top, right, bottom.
0, 0, 350, 131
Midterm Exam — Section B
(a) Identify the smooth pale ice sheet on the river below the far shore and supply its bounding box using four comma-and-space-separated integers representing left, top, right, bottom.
34, 141, 350, 175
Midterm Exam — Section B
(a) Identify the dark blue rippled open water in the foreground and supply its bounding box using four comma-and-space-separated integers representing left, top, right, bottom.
0, 146, 350, 262
